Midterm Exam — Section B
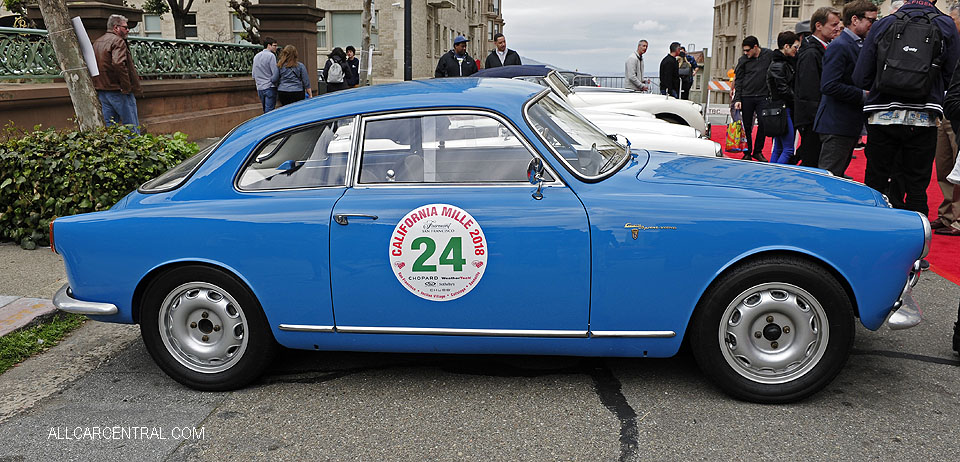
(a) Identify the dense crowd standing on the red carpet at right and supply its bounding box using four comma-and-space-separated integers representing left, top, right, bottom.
728, 0, 960, 236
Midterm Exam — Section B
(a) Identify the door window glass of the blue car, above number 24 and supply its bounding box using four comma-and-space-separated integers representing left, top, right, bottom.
360, 114, 552, 184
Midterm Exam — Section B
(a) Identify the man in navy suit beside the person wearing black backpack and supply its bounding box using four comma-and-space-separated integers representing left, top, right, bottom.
813, 0, 877, 176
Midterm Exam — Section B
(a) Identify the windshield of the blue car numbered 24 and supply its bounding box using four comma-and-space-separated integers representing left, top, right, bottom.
527, 92, 627, 180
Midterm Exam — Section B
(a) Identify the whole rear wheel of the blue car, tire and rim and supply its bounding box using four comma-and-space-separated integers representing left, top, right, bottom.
140, 265, 277, 391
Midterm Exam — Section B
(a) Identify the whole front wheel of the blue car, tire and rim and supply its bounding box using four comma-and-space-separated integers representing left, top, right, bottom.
688, 257, 855, 403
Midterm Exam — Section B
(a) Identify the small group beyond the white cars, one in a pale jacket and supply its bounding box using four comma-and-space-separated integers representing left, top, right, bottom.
623, 40, 703, 100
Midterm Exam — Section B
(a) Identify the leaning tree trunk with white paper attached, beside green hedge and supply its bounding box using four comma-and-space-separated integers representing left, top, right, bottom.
39, 0, 103, 131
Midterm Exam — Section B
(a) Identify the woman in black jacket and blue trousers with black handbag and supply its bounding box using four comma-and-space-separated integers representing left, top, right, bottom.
767, 31, 800, 164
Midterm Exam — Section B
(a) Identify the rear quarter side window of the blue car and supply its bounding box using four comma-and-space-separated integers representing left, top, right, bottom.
240, 117, 354, 191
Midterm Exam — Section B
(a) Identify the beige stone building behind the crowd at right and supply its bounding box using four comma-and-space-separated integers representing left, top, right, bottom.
710, 0, 950, 103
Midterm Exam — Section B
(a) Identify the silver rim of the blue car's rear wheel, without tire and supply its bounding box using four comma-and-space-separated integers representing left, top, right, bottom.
159, 282, 247, 374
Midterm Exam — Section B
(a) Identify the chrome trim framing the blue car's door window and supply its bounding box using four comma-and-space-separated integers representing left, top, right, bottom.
348, 108, 566, 189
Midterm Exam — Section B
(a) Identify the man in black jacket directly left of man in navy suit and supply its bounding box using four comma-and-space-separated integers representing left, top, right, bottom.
793, 6, 843, 167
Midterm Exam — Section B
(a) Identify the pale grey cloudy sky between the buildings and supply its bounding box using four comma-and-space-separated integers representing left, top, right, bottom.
501, 0, 713, 75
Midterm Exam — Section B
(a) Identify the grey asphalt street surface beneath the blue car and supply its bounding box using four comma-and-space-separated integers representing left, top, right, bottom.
0, 240, 960, 461
